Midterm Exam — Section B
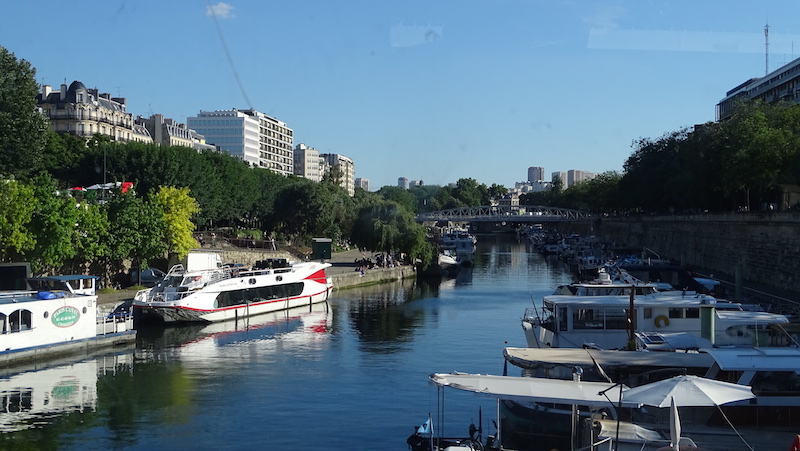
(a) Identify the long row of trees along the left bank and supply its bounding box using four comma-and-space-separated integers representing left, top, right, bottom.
0, 47, 505, 282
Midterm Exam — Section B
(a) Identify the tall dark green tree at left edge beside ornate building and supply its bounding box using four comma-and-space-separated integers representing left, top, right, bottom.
0, 46, 48, 177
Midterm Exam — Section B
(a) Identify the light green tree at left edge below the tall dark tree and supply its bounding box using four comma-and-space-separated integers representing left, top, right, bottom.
0, 177, 36, 262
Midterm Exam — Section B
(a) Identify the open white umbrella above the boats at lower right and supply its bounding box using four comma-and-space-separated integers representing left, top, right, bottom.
622, 375, 755, 407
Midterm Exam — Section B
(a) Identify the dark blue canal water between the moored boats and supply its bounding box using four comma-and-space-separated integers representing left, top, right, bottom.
0, 235, 572, 450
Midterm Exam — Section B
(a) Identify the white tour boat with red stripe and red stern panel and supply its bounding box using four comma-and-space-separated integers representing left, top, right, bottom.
133, 250, 333, 323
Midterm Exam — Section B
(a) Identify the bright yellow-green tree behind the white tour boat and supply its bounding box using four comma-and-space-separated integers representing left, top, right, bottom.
153, 186, 200, 260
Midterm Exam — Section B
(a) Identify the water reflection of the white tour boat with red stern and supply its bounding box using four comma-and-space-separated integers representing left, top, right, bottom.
137, 302, 333, 360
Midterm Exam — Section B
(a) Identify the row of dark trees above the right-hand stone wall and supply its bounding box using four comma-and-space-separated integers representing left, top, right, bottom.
521, 101, 800, 213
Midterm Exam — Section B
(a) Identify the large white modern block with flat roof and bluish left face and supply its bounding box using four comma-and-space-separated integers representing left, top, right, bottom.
186, 108, 294, 175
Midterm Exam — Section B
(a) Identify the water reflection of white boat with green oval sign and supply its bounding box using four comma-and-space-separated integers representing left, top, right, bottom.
0, 354, 132, 433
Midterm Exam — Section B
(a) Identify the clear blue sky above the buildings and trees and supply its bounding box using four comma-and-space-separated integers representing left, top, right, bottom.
0, 0, 800, 190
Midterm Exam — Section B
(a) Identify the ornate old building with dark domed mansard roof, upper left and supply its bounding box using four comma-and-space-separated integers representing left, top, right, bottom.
36, 80, 135, 142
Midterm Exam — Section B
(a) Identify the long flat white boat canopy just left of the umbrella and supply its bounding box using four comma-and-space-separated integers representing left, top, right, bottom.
429, 373, 640, 408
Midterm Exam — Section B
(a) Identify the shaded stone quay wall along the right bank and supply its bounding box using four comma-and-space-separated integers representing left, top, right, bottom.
583, 212, 800, 293
